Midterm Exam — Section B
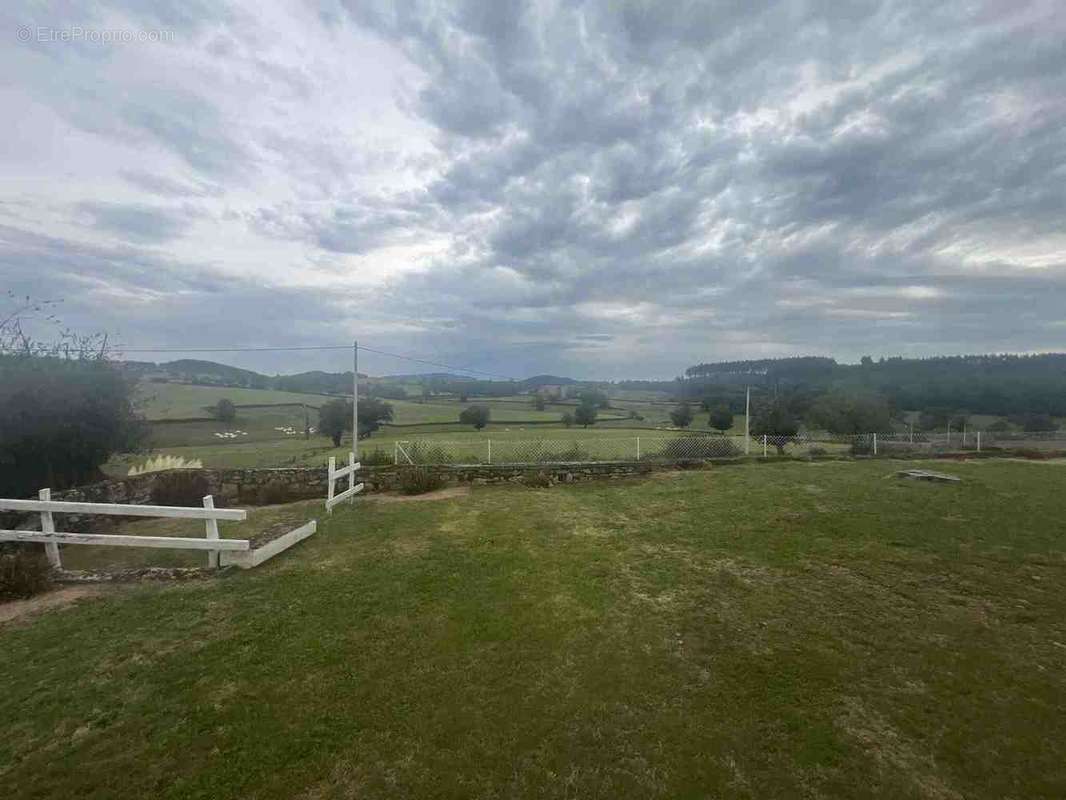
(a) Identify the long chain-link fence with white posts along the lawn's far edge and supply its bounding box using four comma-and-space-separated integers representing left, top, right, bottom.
379, 431, 1066, 465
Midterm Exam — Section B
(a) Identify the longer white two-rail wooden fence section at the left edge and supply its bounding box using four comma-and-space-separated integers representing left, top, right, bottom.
0, 489, 247, 570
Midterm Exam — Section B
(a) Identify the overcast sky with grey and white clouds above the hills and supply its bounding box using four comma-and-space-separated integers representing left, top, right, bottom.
0, 0, 1066, 378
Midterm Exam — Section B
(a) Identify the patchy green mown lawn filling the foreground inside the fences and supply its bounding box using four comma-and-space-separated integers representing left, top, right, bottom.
0, 461, 1066, 800
